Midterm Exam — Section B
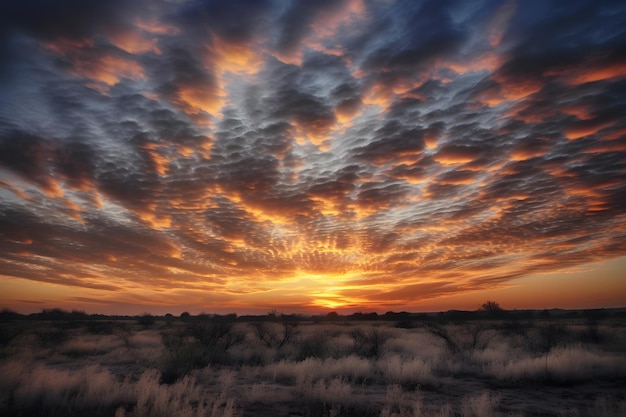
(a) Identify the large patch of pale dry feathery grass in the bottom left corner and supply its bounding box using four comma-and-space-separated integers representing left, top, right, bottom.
0, 365, 237, 417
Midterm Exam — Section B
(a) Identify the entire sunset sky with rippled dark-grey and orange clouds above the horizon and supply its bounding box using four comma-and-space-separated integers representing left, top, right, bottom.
0, 0, 626, 314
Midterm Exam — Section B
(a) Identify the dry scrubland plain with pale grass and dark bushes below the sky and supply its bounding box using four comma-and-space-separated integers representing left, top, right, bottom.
0, 309, 626, 417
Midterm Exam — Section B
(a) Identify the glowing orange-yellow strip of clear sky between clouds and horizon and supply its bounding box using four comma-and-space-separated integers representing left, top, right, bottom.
0, 258, 626, 315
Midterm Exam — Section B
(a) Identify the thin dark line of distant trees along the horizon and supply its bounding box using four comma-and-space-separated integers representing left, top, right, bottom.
0, 308, 626, 326
